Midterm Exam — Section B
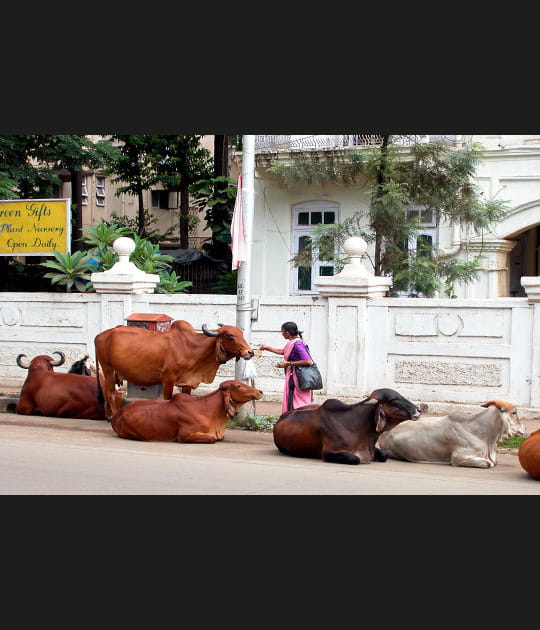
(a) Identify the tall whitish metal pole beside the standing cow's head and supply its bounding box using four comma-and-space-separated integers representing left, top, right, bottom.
234, 135, 255, 422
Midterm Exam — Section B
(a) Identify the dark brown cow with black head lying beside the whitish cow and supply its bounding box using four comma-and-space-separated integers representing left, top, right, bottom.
274, 389, 421, 464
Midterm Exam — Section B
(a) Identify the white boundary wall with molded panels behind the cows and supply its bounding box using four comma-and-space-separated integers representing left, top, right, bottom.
0, 288, 540, 409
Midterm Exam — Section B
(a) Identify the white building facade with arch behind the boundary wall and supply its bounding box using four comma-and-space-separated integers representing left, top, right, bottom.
233, 135, 540, 298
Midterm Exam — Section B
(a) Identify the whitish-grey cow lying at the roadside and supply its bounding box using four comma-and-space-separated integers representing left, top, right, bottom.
377, 400, 525, 468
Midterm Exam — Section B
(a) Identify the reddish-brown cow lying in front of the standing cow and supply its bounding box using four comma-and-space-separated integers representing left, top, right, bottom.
111, 380, 262, 444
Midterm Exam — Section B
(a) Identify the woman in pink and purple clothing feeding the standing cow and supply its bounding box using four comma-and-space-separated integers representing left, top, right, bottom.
260, 322, 313, 413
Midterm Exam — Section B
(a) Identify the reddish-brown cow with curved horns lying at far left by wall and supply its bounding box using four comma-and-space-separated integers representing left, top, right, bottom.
15, 352, 121, 420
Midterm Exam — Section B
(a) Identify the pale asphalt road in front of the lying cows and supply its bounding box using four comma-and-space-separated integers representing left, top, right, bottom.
0, 413, 540, 495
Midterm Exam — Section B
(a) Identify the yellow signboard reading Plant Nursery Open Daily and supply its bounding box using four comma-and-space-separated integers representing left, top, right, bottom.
0, 199, 71, 256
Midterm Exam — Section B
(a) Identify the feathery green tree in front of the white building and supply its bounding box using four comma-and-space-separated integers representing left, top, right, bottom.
269, 135, 507, 297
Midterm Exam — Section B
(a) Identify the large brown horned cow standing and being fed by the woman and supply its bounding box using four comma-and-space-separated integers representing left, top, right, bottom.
94, 319, 254, 420
